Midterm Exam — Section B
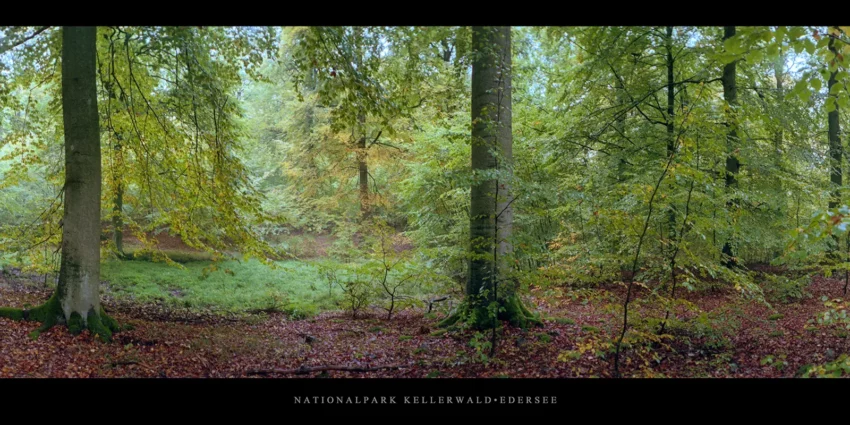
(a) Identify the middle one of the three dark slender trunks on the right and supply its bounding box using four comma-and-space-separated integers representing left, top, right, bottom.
723, 27, 740, 267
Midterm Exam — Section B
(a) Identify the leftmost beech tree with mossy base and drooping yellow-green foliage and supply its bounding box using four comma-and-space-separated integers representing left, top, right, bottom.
0, 27, 271, 340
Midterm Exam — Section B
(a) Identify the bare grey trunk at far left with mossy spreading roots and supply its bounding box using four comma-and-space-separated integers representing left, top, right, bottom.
0, 27, 117, 340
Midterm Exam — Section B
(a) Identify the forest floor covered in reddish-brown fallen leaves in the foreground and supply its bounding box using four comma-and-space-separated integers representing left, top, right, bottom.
0, 264, 848, 378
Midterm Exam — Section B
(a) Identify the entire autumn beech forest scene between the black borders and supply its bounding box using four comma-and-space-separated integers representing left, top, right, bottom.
0, 26, 850, 378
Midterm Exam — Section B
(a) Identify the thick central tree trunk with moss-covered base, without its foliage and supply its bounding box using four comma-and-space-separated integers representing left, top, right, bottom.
443, 27, 537, 329
